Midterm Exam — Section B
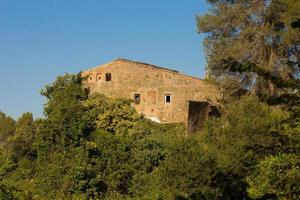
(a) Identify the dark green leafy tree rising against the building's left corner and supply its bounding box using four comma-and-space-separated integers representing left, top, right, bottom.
37, 74, 88, 150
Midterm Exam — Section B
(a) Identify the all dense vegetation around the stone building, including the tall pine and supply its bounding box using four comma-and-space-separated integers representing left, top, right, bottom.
0, 0, 300, 200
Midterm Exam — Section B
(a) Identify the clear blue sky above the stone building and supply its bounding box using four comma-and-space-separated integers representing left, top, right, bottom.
0, 0, 208, 118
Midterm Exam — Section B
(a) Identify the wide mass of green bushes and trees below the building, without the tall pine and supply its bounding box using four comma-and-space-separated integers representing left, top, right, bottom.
0, 72, 300, 200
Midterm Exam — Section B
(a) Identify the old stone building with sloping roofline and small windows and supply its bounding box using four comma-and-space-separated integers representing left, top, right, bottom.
83, 59, 218, 132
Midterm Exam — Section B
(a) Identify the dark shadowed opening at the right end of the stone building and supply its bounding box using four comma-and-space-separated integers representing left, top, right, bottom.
187, 101, 220, 133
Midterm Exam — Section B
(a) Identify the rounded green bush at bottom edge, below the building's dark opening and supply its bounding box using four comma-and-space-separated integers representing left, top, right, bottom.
147, 137, 220, 199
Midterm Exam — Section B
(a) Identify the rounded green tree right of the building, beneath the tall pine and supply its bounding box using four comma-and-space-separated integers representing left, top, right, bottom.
200, 97, 290, 199
